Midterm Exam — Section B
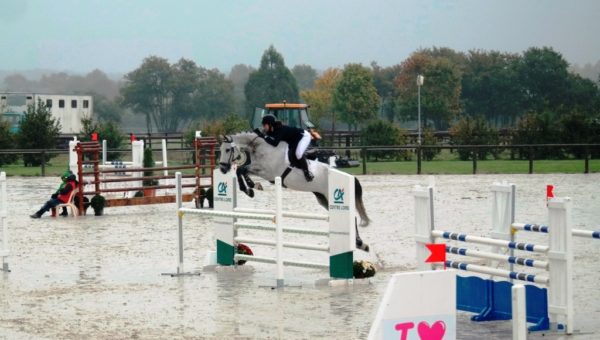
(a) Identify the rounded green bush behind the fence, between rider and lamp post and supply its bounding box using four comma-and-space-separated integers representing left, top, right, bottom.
361, 120, 411, 161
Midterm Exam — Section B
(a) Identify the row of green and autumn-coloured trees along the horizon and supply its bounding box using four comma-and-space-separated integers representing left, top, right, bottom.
5, 46, 600, 142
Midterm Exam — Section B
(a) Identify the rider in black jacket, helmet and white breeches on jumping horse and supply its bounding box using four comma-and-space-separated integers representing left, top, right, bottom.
254, 115, 314, 182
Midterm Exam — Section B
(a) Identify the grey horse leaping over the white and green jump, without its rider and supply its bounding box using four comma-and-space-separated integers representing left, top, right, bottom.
219, 132, 370, 251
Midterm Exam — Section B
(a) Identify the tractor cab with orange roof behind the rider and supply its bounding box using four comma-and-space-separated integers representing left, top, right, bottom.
252, 102, 321, 144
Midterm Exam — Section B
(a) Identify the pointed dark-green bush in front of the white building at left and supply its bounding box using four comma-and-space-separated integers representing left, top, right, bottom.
17, 99, 60, 166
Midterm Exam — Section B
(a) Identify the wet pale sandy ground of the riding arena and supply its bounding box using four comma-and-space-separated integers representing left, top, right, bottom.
0, 174, 600, 339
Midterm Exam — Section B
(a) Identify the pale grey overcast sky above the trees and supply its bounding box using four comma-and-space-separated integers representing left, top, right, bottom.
0, 0, 600, 73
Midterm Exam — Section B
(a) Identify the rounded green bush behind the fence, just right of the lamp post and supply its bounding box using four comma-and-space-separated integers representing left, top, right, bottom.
450, 116, 499, 161
